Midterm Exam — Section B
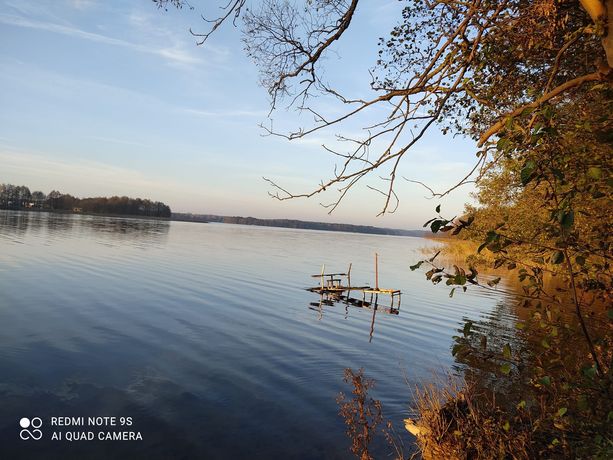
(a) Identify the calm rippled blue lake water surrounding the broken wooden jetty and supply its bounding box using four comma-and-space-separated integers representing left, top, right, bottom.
0, 211, 514, 459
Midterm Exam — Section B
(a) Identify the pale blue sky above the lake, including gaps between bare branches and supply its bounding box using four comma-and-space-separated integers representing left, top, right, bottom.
0, 0, 475, 228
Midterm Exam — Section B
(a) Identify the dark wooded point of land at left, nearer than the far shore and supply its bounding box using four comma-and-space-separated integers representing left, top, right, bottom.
0, 184, 171, 217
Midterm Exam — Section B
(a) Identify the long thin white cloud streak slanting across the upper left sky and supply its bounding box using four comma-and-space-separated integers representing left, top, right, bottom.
0, 14, 203, 65
